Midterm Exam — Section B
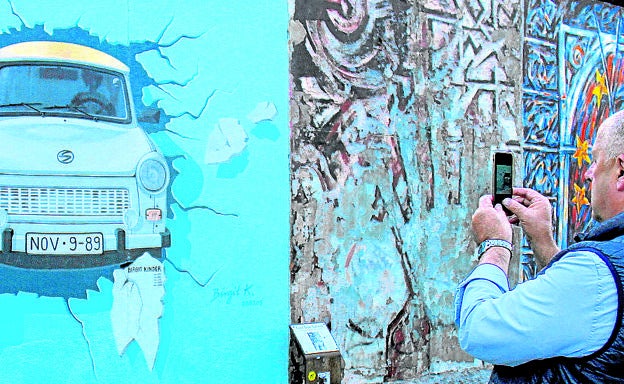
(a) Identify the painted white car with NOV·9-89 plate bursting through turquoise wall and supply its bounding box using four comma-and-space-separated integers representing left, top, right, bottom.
0, 41, 171, 269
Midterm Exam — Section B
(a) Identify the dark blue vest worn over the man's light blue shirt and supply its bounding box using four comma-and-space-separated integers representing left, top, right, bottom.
490, 213, 624, 383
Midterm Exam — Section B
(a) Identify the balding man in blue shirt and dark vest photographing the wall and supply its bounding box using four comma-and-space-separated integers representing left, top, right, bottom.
455, 111, 624, 383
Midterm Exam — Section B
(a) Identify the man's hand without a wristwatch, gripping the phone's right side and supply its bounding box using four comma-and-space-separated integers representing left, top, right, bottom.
503, 188, 559, 269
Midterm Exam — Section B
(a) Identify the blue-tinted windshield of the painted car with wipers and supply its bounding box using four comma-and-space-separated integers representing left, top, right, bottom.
0, 64, 130, 122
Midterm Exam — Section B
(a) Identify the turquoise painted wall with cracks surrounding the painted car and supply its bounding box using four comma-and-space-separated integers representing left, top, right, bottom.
0, 0, 290, 384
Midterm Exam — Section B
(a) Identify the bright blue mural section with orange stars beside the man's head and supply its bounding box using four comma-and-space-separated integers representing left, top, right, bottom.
523, 2, 624, 278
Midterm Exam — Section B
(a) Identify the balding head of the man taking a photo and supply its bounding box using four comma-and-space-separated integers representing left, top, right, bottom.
585, 111, 624, 221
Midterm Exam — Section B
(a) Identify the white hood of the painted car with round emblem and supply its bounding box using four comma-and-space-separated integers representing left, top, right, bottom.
0, 116, 153, 176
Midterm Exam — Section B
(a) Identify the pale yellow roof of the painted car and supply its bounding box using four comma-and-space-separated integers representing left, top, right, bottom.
0, 41, 129, 72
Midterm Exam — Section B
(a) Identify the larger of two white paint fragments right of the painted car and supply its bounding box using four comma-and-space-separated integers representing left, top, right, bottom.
204, 119, 248, 164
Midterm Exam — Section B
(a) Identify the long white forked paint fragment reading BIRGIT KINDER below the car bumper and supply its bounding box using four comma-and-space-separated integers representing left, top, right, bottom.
111, 253, 165, 370
